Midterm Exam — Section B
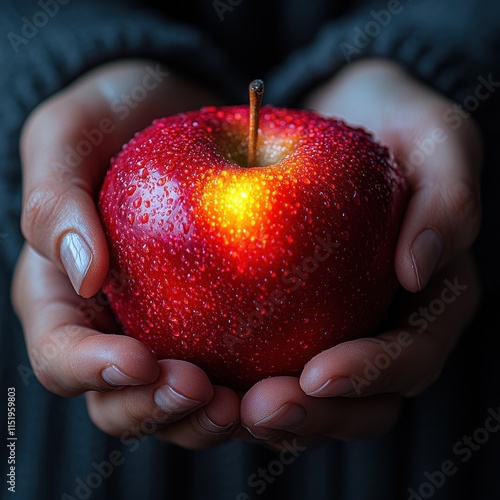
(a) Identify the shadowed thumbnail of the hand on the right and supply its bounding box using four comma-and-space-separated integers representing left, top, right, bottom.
411, 228, 443, 290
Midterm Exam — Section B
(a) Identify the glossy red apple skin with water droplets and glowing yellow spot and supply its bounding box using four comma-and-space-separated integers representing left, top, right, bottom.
99, 106, 407, 389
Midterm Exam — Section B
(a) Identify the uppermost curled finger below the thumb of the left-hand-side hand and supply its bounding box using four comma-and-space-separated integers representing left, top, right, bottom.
13, 247, 159, 396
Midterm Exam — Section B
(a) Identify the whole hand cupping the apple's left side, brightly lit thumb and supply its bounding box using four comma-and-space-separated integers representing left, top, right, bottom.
13, 60, 239, 448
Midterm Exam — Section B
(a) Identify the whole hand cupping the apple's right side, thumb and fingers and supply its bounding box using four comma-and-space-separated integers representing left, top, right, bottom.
241, 61, 481, 447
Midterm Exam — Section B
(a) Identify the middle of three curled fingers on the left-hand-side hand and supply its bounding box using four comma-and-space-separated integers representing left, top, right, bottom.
87, 360, 214, 436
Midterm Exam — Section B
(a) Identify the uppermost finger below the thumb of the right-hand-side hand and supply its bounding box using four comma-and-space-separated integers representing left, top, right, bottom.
300, 252, 478, 398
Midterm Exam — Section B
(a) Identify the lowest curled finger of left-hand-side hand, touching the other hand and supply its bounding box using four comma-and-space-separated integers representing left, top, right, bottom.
155, 386, 240, 450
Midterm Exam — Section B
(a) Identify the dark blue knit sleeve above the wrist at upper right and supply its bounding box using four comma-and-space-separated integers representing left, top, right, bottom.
268, 0, 500, 105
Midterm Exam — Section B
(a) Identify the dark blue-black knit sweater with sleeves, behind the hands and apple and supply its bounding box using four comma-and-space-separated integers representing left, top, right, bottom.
0, 0, 500, 500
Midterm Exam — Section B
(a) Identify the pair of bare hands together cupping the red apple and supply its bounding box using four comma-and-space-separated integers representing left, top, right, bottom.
13, 60, 481, 448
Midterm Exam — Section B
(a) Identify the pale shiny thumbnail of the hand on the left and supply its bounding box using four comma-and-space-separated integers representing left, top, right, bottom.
61, 233, 92, 293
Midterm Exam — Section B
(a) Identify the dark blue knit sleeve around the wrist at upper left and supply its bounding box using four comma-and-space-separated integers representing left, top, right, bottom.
0, 0, 238, 269
